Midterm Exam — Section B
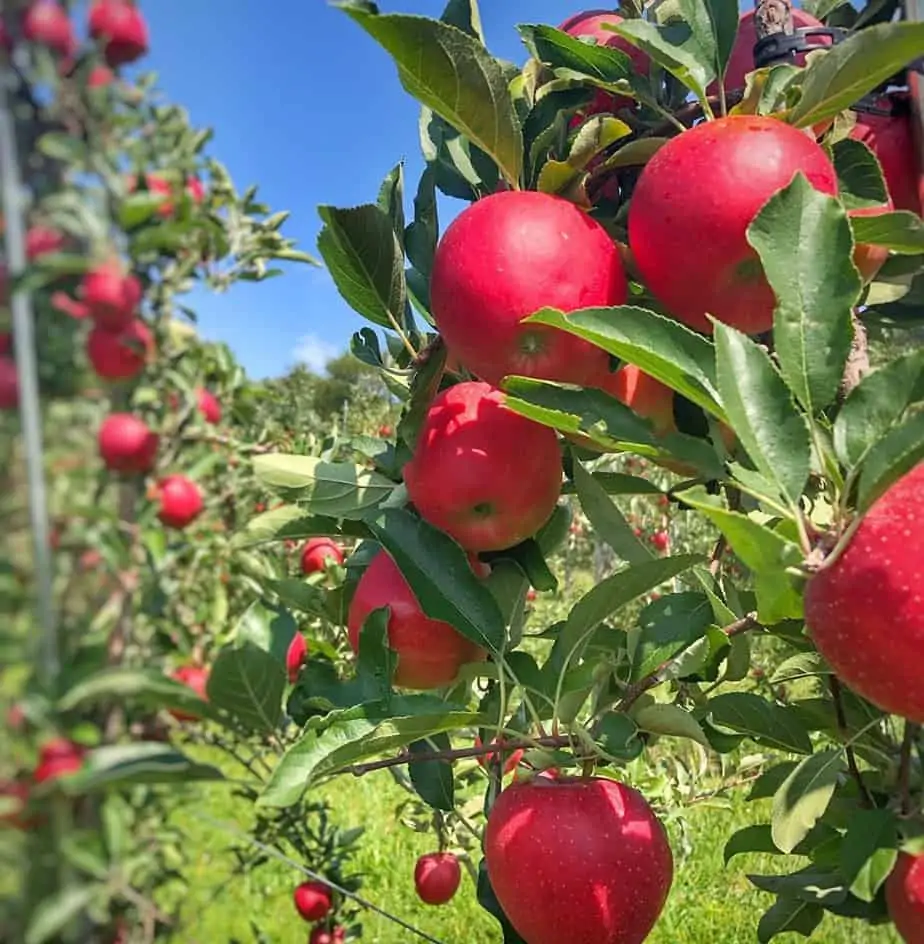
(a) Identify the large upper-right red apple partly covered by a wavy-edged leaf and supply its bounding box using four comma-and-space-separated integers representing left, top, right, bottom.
628, 115, 837, 334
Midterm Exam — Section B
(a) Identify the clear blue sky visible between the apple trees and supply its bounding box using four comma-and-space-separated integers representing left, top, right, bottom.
142, 0, 590, 378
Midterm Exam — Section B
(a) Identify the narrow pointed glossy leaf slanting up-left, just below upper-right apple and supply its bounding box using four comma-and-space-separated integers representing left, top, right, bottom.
715, 322, 811, 505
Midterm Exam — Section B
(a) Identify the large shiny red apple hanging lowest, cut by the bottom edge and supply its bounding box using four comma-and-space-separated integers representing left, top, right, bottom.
485, 776, 673, 944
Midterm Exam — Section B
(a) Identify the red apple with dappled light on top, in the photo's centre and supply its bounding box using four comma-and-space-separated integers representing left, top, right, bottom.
404, 381, 561, 551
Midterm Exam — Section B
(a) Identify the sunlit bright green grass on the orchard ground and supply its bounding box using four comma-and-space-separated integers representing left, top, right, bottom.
162, 771, 899, 944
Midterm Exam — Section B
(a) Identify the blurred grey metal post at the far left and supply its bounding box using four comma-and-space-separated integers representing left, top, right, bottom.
0, 66, 60, 688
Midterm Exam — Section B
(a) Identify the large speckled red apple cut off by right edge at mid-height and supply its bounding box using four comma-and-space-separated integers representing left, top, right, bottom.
805, 463, 924, 723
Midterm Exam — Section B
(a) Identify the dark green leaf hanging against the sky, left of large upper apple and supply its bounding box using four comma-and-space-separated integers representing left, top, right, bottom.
318, 203, 407, 328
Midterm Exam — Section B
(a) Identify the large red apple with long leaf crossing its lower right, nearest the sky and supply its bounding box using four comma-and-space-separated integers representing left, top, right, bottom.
430, 190, 627, 384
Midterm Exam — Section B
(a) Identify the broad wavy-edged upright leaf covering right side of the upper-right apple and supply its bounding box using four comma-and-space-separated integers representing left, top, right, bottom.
747, 173, 862, 413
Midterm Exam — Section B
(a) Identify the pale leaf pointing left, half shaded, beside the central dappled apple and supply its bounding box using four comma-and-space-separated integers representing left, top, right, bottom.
253, 453, 396, 518
